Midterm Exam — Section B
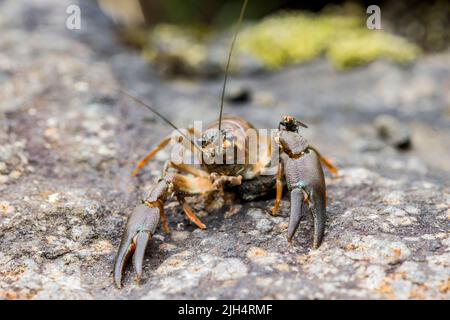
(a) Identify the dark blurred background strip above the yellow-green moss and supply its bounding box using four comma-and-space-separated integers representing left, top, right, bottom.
98, 0, 449, 51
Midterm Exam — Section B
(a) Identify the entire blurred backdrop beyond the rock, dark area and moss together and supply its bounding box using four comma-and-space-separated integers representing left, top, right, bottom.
98, 0, 450, 73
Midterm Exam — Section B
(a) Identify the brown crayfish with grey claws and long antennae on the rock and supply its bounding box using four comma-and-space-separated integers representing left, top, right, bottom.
114, 1, 337, 288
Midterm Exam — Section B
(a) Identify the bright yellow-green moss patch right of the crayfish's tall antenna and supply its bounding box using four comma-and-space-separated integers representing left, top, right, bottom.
238, 12, 419, 69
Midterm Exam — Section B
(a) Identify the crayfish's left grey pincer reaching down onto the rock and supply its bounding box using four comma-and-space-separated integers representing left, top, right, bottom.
114, 204, 161, 288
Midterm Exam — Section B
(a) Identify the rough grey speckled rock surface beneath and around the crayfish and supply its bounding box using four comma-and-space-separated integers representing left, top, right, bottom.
0, 0, 450, 299
